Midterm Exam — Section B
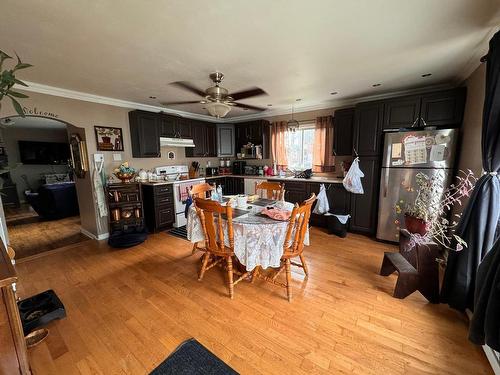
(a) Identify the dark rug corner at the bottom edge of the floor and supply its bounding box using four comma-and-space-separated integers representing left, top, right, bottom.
150, 338, 238, 375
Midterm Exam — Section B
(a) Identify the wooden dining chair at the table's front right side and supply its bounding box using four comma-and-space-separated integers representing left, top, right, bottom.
252, 193, 316, 302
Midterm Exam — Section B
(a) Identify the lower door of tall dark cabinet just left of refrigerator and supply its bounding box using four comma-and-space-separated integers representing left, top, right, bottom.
350, 156, 380, 234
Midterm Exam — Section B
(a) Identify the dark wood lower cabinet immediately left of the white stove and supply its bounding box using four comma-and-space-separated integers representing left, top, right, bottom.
142, 184, 175, 232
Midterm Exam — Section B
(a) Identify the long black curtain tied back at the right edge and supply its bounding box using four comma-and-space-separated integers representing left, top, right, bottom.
441, 32, 500, 344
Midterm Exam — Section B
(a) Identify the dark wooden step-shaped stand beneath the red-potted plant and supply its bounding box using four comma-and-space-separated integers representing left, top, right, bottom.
380, 230, 439, 303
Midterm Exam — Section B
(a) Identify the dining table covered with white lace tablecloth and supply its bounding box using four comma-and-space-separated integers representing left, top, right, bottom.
186, 198, 309, 271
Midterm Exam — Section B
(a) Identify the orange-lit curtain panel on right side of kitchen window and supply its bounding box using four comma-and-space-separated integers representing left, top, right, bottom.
313, 116, 335, 172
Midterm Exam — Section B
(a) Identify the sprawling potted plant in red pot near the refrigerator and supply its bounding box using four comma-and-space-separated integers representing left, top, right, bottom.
394, 170, 477, 251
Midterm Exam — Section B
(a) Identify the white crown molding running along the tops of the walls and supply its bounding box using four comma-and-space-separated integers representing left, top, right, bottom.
16, 81, 454, 123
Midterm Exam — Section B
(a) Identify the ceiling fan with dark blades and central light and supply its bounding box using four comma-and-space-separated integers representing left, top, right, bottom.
161, 72, 267, 118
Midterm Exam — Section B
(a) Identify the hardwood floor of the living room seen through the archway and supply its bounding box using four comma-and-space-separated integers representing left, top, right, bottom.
5, 205, 89, 259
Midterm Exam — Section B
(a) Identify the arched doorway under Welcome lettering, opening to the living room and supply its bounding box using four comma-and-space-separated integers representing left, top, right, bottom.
0, 116, 89, 260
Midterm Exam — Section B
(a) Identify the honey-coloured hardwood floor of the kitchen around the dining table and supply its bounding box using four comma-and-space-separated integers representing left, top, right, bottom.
13, 228, 492, 375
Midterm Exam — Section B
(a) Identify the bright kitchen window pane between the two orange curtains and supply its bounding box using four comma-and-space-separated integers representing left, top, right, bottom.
285, 123, 315, 170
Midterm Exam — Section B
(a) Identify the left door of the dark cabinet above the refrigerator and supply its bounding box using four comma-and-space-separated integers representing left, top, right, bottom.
383, 96, 421, 129
